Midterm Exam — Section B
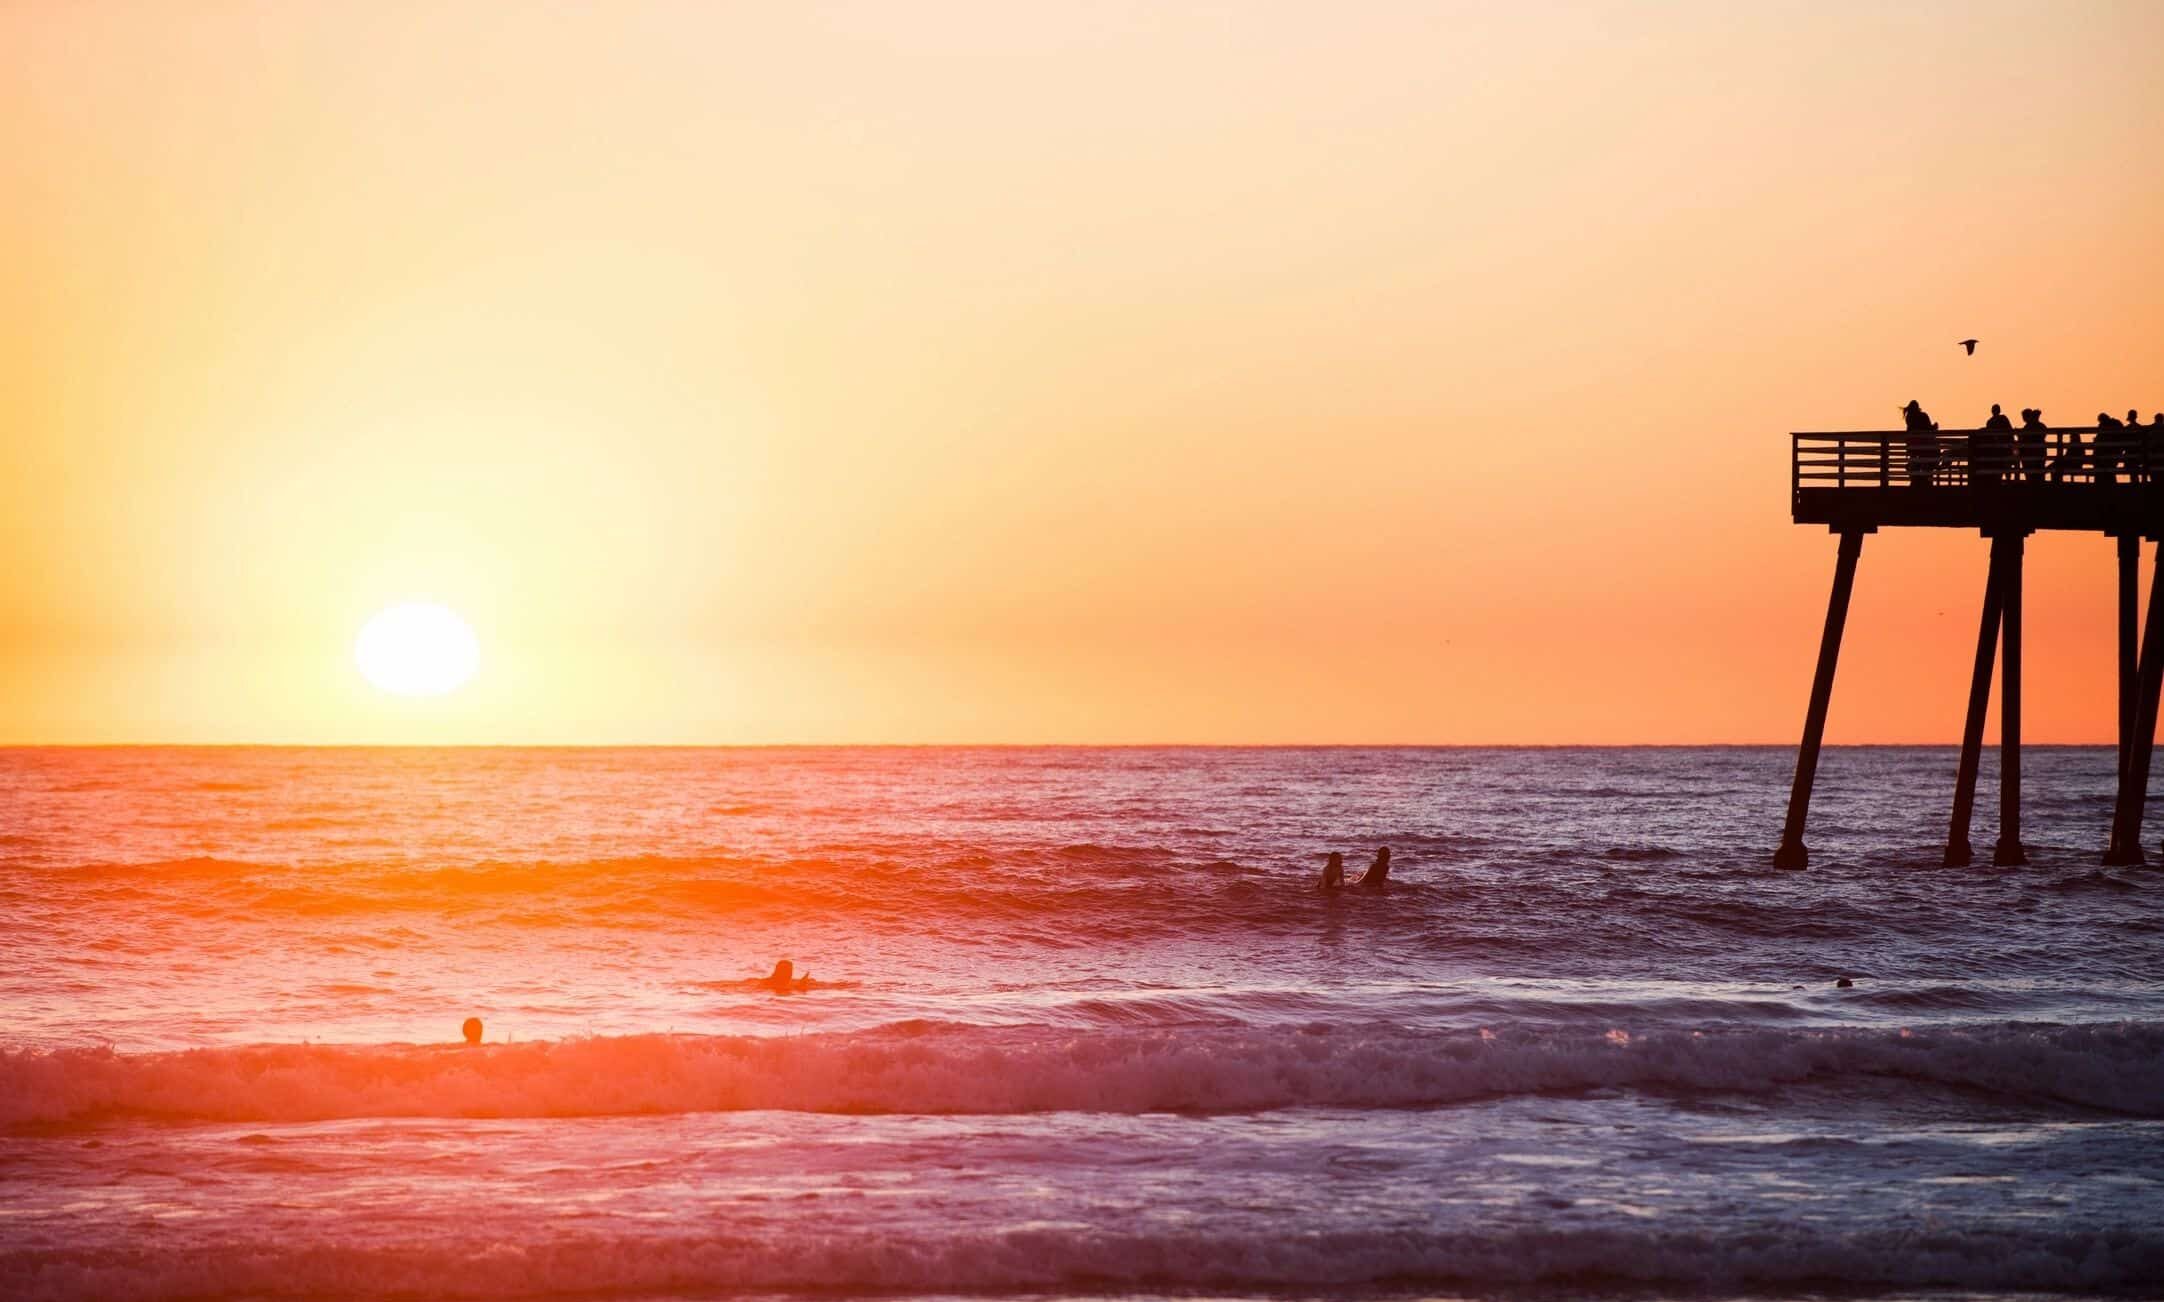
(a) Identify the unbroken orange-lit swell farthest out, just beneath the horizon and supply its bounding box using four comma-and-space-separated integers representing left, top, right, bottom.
0, 843, 1912, 925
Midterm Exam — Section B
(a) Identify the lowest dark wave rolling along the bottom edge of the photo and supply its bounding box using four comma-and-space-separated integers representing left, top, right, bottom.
0, 1218, 2164, 1302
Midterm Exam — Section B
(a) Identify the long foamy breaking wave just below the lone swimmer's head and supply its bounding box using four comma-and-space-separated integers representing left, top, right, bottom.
0, 1021, 2164, 1127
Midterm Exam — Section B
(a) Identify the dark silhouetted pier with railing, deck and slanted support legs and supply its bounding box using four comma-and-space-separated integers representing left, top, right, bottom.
1772, 426, 2164, 867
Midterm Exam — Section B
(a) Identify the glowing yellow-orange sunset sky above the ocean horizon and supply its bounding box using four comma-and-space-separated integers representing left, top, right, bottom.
0, 0, 2164, 744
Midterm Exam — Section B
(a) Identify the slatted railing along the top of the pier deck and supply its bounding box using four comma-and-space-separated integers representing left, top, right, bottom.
1790, 426, 2164, 493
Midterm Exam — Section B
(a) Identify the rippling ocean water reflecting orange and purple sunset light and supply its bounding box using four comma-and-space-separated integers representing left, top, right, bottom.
0, 748, 2164, 1300
